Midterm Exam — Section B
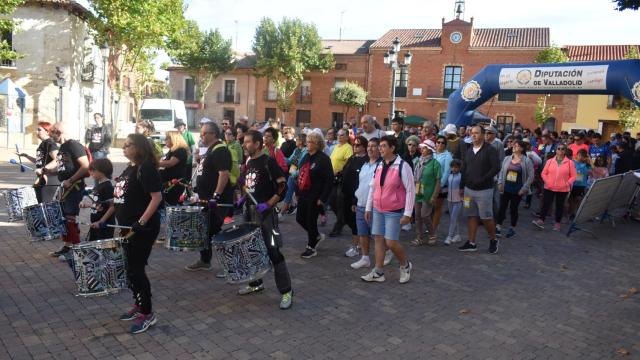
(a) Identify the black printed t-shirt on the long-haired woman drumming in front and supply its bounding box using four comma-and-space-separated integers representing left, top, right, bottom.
113, 162, 162, 226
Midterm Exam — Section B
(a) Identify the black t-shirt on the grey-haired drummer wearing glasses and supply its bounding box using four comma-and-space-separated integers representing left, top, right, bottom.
196, 142, 233, 203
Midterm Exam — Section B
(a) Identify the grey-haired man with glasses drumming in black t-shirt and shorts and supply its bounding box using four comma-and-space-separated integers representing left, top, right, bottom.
185, 122, 233, 272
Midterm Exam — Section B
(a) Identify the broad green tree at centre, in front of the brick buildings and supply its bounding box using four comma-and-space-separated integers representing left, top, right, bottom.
253, 18, 335, 123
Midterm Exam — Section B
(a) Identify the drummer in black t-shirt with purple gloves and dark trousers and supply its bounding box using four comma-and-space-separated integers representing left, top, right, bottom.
238, 130, 293, 310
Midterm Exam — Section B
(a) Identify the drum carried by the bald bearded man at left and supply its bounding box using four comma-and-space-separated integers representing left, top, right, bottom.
22, 201, 67, 241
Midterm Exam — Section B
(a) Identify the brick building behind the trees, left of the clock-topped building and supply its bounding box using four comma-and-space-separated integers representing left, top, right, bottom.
251, 40, 374, 128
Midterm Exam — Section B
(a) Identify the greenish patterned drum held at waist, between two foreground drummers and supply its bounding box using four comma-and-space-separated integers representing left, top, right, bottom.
165, 206, 209, 251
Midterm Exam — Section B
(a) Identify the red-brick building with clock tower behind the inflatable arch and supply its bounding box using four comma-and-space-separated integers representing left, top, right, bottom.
368, 18, 576, 130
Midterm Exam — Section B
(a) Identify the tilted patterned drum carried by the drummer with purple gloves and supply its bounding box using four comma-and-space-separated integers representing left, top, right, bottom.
213, 224, 271, 284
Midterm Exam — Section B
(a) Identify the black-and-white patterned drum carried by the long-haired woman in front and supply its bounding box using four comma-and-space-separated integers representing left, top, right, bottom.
71, 238, 129, 296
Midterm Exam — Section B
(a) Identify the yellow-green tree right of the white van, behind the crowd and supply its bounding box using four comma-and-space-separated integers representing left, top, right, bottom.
169, 20, 235, 114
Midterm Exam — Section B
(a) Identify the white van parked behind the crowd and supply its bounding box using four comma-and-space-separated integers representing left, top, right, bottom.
140, 99, 187, 142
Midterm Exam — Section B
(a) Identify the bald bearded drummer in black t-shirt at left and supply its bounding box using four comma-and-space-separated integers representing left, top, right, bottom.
42, 123, 89, 257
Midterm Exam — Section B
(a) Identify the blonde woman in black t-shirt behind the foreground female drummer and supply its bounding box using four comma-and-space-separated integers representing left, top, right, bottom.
160, 131, 191, 205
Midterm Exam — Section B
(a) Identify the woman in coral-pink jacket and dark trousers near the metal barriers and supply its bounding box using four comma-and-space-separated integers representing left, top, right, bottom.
533, 144, 576, 231
